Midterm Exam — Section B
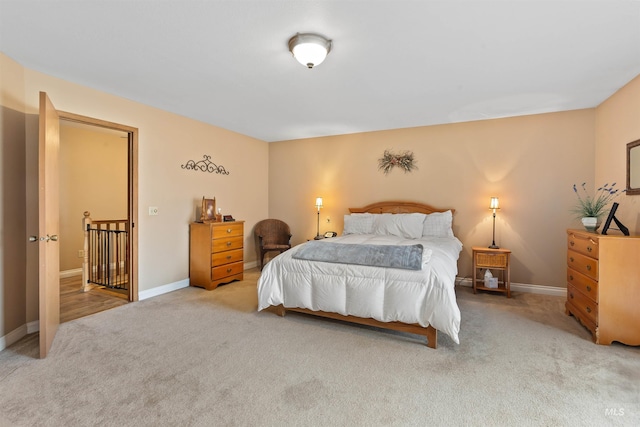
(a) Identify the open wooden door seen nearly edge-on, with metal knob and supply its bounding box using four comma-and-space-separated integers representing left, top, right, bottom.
38, 92, 60, 358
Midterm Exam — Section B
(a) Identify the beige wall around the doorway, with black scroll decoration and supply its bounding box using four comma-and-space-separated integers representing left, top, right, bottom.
25, 69, 268, 298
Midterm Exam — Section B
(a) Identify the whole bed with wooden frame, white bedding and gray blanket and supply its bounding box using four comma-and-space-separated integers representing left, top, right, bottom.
258, 201, 462, 348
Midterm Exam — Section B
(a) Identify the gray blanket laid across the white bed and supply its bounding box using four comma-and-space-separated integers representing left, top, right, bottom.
293, 241, 422, 270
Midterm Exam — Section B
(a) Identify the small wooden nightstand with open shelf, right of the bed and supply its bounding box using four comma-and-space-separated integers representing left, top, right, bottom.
471, 246, 511, 298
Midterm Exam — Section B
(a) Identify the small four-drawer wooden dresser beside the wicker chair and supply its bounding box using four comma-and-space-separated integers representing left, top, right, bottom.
189, 221, 244, 290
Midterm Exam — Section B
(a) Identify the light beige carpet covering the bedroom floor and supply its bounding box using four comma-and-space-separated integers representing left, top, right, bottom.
0, 270, 640, 426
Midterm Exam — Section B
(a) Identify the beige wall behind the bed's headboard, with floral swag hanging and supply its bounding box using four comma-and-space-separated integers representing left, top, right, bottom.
269, 109, 595, 287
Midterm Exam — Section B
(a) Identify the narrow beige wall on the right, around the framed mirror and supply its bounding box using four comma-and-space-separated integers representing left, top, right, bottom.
595, 76, 640, 234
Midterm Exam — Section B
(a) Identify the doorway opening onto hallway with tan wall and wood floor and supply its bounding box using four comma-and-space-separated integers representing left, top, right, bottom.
59, 112, 138, 322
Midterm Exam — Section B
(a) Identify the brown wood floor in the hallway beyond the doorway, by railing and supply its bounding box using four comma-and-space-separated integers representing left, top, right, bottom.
60, 276, 128, 323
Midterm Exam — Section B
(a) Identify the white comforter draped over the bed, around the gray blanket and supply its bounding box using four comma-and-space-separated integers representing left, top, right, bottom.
258, 234, 462, 344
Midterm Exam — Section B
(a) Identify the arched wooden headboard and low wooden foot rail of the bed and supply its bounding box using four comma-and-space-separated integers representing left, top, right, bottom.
275, 201, 455, 349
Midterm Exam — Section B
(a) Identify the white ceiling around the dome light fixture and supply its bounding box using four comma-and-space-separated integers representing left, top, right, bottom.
0, 0, 640, 141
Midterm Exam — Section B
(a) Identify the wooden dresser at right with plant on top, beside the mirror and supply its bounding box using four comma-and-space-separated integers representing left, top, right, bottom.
565, 230, 640, 345
